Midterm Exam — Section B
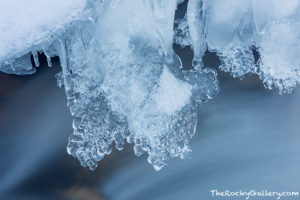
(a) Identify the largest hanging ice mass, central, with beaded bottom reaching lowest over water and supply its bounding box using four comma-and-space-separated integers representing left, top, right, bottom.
61, 0, 218, 170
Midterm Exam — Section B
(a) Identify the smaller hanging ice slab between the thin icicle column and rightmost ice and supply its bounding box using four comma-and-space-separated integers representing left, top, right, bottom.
206, 0, 255, 77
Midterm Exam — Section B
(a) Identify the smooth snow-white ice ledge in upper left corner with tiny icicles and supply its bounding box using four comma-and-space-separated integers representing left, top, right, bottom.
0, 0, 94, 74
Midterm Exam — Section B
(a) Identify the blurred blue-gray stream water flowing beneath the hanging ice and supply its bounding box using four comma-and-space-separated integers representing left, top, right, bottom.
0, 56, 300, 200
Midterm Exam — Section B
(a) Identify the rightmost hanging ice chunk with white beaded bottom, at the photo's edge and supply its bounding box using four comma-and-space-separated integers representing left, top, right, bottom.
253, 0, 300, 93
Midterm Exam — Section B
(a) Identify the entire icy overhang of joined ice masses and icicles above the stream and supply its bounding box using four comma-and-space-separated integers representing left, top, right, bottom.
0, 0, 300, 170
